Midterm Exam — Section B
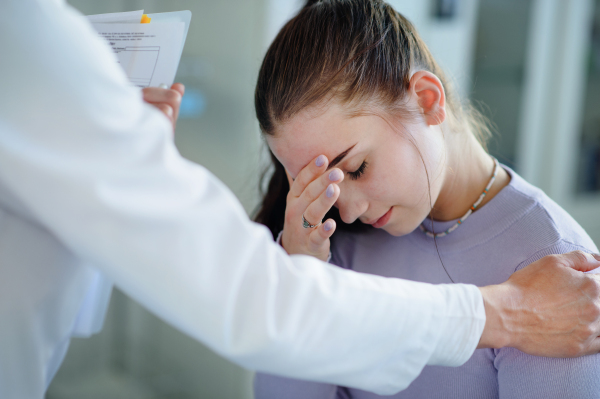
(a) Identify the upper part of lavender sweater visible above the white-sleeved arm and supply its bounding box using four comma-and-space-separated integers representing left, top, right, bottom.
331, 168, 597, 285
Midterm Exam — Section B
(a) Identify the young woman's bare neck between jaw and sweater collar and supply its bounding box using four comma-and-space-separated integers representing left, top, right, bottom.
431, 134, 510, 221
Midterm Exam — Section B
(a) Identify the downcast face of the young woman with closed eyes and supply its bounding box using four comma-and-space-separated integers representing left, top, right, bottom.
267, 104, 446, 236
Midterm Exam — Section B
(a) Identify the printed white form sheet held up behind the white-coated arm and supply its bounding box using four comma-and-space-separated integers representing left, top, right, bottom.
93, 21, 185, 87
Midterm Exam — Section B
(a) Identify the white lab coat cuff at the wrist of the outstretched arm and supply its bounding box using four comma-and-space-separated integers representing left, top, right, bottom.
427, 284, 485, 367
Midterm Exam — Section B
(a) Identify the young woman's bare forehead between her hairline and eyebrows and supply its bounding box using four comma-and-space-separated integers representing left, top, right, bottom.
267, 105, 361, 178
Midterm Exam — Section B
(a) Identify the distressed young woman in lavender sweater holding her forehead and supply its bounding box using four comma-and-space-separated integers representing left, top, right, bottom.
255, 0, 600, 399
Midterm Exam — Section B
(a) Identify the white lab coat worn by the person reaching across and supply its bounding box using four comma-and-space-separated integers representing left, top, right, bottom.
0, 0, 485, 399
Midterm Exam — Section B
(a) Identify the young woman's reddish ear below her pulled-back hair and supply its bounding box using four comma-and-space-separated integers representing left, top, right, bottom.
410, 71, 446, 126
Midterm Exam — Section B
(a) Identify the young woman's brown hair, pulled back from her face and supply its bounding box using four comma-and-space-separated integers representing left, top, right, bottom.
254, 0, 489, 241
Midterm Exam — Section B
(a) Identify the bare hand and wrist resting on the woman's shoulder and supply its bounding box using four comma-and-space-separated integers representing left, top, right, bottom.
478, 252, 600, 357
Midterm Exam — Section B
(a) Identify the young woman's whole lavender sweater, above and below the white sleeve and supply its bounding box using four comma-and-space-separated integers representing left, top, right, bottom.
254, 167, 600, 399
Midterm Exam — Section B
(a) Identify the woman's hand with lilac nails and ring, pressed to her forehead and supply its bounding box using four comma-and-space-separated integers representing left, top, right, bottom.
281, 155, 344, 261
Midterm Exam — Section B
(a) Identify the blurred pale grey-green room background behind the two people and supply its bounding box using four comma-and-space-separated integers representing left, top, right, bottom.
47, 0, 600, 399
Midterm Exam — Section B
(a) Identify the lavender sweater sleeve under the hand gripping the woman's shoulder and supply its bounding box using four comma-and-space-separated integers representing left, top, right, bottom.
494, 241, 600, 399
